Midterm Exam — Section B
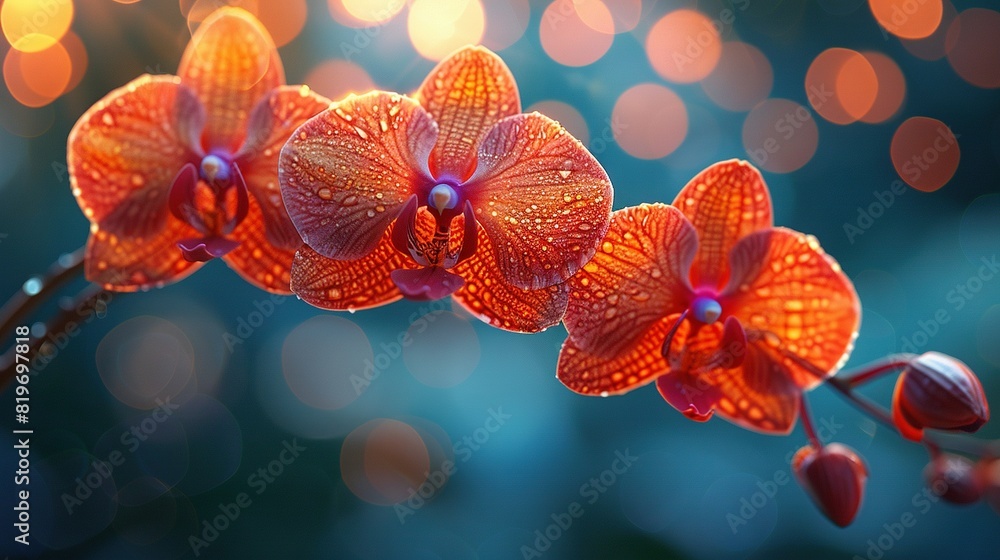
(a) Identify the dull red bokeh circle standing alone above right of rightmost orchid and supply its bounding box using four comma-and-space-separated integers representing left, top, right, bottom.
890, 117, 961, 192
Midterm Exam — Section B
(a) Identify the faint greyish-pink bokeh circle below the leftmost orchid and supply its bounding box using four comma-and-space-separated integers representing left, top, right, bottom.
95, 315, 196, 409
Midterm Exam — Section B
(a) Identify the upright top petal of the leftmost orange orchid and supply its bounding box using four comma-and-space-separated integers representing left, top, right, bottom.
177, 7, 285, 154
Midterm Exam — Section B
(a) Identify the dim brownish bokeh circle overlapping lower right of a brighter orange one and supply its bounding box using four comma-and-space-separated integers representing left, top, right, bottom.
701, 41, 774, 111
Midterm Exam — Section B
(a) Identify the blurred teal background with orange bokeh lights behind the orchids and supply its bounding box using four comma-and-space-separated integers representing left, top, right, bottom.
0, 0, 1000, 560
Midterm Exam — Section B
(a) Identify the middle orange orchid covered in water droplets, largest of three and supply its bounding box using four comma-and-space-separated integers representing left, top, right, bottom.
279, 47, 612, 332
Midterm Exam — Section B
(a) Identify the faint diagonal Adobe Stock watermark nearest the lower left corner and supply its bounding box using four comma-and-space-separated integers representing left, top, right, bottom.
60, 397, 180, 515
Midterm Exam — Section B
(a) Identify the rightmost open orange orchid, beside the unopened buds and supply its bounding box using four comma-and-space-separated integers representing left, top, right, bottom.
558, 160, 860, 433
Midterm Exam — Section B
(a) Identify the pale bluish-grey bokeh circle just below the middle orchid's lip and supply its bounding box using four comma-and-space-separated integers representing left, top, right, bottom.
403, 311, 480, 388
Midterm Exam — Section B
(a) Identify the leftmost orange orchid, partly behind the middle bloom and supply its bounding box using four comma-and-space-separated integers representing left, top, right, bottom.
67, 8, 330, 293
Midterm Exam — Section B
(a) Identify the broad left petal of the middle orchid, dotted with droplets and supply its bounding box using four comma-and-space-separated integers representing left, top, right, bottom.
278, 91, 437, 260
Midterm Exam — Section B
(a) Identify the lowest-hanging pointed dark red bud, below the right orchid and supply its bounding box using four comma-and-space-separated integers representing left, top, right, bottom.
792, 443, 868, 527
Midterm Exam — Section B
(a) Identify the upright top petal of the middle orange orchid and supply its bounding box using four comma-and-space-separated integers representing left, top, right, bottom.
415, 47, 521, 182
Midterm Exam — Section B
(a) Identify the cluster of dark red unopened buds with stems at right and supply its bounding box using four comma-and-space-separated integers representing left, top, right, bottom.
792, 352, 1000, 527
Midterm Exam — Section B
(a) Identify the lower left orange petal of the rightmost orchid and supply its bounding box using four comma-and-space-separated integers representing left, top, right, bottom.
556, 315, 679, 396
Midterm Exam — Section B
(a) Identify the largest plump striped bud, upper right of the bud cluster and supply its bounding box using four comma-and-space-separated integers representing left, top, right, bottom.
892, 352, 990, 441
